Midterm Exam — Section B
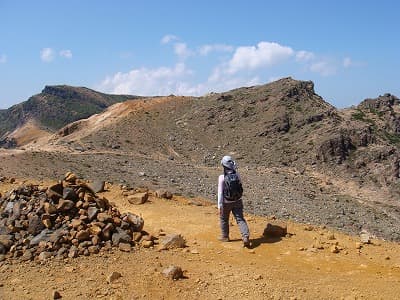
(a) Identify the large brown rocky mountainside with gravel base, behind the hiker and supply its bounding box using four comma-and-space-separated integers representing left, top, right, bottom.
0, 78, 400, 241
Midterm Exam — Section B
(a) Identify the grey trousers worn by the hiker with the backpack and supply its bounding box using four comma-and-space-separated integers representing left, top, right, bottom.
219, 200, 250, 240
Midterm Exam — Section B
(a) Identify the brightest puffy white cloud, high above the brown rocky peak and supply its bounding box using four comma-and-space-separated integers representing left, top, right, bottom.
228, 42, 294, 73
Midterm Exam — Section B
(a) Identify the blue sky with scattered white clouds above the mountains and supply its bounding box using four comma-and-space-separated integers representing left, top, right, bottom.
0, 0, 400, 108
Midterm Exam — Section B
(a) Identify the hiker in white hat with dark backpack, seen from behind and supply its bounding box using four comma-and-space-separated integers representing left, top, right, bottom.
218, 155, 250, 248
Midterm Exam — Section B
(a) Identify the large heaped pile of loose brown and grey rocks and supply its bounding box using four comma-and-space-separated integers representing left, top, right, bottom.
0, 173, 144, 260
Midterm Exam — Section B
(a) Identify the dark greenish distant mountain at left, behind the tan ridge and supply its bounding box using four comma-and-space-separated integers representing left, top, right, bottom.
0, 85, 137, 147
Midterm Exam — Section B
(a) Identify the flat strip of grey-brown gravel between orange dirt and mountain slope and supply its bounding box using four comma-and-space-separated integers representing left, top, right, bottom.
0, 150, 400, 241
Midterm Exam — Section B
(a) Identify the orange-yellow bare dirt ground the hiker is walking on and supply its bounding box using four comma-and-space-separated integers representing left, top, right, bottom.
0, 180, 400, 299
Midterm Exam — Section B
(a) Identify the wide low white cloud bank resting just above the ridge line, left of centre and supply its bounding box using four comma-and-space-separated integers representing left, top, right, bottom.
98, 63, 198, 95
